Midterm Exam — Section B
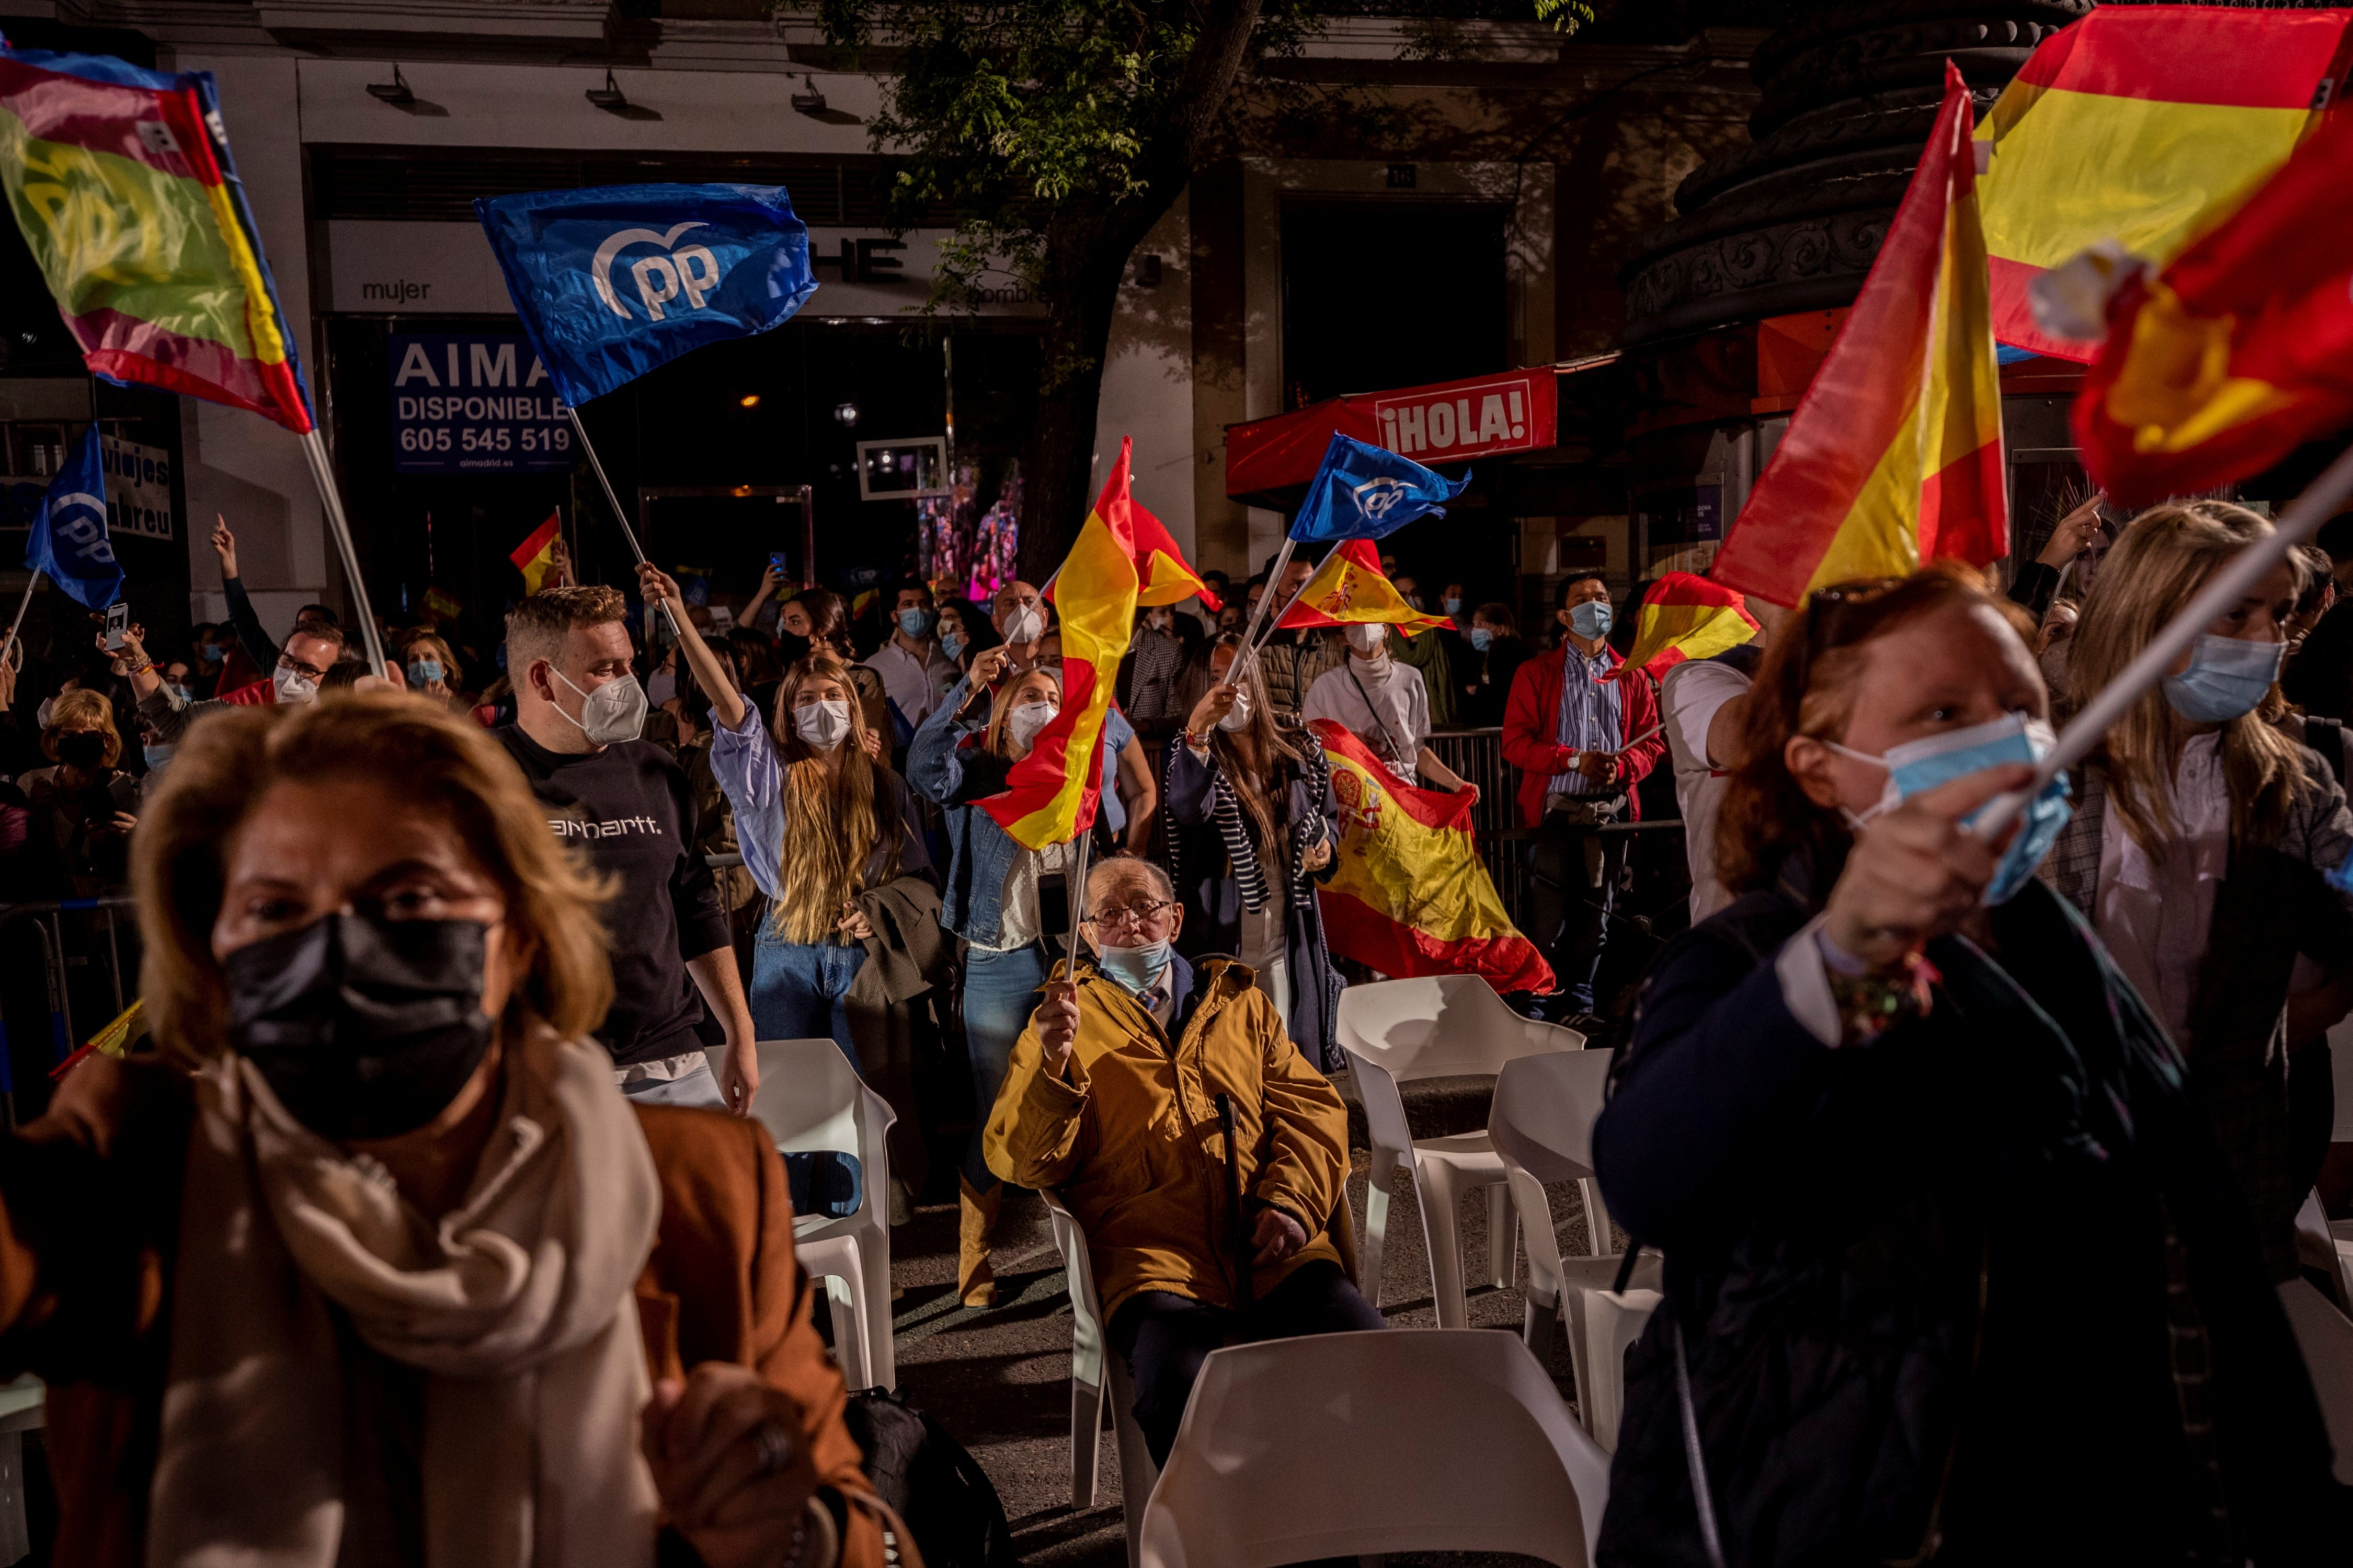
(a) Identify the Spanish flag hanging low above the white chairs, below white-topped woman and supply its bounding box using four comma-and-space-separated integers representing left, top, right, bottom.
1308, 718, 1553, 991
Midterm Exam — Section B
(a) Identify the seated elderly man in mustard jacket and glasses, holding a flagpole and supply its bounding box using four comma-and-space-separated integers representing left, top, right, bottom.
984, 860, 1384, 1464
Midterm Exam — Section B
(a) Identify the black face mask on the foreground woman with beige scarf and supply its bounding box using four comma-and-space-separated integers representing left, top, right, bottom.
221, 913, 497, 1142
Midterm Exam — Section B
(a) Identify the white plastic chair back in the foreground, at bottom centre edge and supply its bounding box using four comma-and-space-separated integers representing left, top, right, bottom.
1141, 1328, 1609, 1568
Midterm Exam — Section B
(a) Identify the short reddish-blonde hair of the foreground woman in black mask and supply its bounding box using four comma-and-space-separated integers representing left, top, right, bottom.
132, 692, 612, 1067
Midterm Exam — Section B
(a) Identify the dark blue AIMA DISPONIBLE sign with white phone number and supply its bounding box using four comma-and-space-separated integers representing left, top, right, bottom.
386, 332, 572, 473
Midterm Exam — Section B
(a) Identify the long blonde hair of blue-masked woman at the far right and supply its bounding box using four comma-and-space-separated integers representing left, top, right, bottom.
2069, 501, 2311, 855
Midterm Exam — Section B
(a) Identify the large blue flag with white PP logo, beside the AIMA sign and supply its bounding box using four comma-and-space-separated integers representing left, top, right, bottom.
473, 186, 817, 407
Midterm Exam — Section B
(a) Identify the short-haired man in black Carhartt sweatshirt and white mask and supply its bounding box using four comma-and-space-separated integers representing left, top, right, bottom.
497, 586, 760, 1116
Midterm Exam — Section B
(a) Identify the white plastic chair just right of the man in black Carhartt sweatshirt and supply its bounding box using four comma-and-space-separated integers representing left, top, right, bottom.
751, 1040, 899, 1389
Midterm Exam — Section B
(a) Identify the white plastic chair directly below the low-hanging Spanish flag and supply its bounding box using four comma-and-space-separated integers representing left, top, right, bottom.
1337, 975, 1586, 1328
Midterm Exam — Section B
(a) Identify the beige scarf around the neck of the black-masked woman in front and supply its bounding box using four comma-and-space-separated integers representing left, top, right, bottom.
149, 1036, 661, 1568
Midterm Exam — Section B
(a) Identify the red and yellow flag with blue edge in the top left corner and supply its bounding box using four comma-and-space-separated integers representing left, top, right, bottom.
0, 47, 311, 433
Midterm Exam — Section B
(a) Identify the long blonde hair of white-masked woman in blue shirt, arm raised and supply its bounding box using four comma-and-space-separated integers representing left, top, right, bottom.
772, 645, 906, 946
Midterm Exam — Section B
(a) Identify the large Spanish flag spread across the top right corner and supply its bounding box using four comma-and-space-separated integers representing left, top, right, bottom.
1977, 5, 2353, 360
